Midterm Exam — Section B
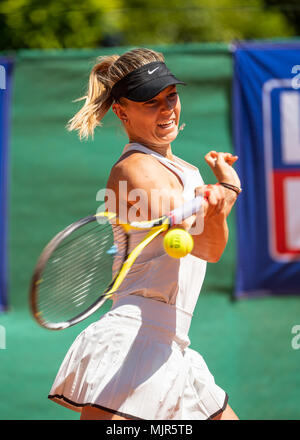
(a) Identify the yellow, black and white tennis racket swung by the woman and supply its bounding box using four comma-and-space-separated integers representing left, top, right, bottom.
29, 196, 203, 330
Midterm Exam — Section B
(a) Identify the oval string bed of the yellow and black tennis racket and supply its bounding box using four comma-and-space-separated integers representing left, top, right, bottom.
38, 221, 127, 322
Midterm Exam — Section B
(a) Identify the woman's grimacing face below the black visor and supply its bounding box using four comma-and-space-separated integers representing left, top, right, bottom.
113, 85, 181, 146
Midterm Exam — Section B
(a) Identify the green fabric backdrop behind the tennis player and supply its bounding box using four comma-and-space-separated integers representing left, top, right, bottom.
0, 44, 300, 419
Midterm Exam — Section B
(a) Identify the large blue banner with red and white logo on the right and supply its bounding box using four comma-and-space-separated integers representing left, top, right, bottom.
233, 42, 300, 297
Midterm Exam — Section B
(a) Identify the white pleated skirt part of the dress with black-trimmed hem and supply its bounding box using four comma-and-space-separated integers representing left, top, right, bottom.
48, 295, 228, 420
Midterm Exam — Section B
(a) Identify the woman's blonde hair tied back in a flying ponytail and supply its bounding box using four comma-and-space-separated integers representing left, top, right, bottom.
67, 48, 164, 140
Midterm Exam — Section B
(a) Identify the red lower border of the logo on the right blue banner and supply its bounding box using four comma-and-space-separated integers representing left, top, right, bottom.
273, 170, 300, 255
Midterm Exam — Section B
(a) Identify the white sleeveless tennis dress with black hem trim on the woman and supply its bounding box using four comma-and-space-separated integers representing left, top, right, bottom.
49, 143, 228, 420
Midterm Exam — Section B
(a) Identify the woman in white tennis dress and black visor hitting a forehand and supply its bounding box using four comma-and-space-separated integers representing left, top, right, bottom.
49, 49, 240, 420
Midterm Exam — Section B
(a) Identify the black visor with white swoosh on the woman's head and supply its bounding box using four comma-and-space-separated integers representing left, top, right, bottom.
111, 61, 185, 102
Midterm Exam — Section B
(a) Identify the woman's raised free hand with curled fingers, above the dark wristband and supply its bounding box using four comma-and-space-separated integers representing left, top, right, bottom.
204, 151, 241, 188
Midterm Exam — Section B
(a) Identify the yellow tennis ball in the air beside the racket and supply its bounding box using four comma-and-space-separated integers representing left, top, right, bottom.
164, 228, 194, 258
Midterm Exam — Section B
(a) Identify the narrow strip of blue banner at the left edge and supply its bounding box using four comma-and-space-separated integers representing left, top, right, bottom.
0, 57, 13, 311
